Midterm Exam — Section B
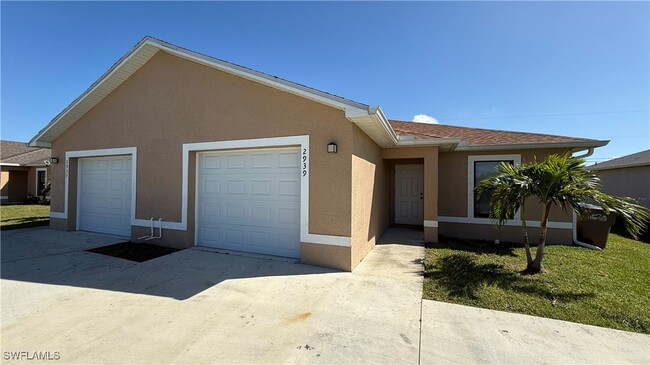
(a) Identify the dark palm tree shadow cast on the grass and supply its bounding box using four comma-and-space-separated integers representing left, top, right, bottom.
424, 253, 595, 303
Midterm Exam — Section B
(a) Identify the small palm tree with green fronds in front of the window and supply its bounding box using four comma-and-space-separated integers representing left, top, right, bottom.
477, 153, 650, 273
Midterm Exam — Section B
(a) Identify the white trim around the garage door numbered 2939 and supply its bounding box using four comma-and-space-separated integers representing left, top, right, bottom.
181, 135, 352, 247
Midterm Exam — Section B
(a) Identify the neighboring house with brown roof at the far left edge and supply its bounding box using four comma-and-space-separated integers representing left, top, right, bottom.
0, 141, 51, 204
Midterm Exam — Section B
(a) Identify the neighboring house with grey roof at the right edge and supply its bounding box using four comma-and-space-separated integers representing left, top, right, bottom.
589, 150, 650, 209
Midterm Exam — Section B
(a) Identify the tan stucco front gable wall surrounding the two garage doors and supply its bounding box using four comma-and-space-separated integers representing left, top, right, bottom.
51, 52, 353, 266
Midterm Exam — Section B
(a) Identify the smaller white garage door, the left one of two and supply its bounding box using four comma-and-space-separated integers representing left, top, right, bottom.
77, 156, 132, 236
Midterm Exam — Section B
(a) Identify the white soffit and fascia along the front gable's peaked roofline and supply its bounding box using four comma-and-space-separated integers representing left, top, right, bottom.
29, 37, 397, 147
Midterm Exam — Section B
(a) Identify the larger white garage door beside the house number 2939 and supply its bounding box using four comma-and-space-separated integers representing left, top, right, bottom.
197, 148, 300, 257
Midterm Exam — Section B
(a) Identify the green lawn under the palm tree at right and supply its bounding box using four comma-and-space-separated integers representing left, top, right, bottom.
424, 234, 650, 333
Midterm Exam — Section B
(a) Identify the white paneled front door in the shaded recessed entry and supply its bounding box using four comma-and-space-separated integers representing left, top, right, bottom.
395, 165, 424, 226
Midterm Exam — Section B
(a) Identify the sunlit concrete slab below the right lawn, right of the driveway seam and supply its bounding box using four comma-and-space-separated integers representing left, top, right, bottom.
421, 300, 650, 364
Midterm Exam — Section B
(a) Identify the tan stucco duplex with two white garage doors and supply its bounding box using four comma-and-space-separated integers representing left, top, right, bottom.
30, 37, 607, 270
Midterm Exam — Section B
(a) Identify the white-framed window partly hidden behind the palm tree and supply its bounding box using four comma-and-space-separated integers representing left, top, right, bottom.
467, 155, 521, 218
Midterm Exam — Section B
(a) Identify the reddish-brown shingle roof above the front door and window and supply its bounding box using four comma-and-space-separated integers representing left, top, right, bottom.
390, 120, 597, 146
